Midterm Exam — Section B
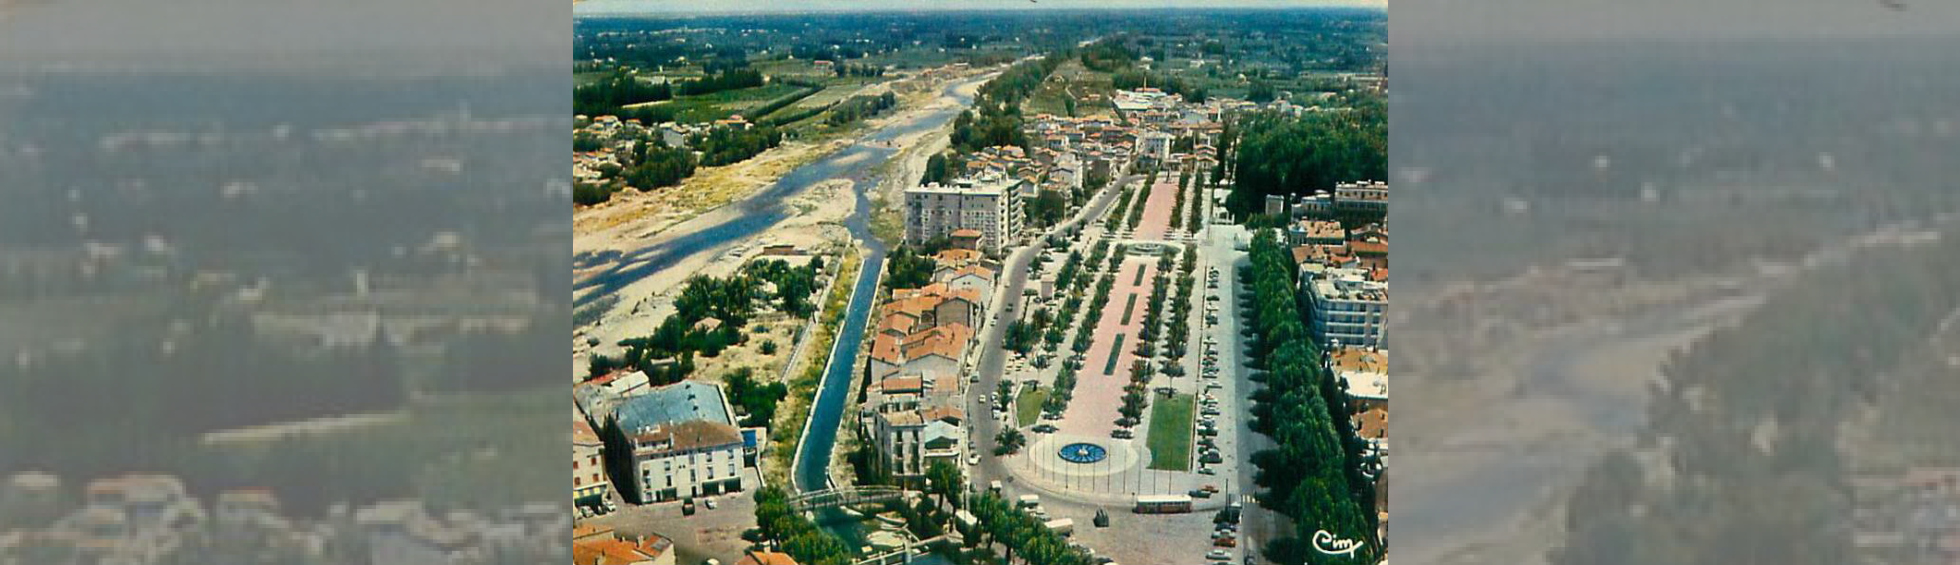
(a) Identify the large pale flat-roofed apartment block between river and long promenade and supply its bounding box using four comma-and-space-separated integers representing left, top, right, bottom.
906, 177, 1027, 251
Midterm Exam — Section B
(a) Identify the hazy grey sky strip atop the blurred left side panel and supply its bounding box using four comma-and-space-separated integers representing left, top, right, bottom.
0, 0, 572, 67
